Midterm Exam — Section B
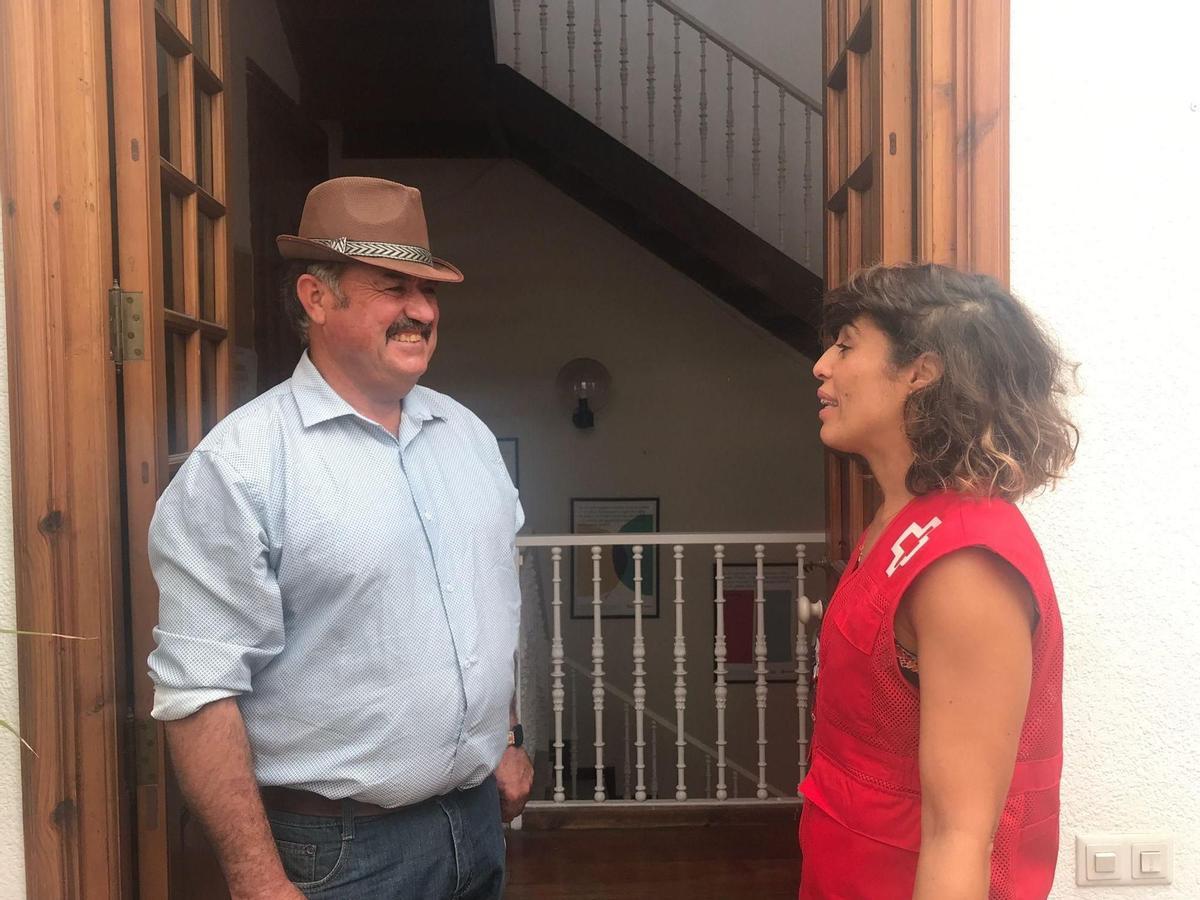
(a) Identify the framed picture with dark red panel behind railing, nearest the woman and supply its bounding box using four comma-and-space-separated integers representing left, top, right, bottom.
713, 563, 796, 684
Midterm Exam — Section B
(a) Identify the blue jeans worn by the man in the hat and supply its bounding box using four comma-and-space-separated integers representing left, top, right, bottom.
266, 776, 504, 900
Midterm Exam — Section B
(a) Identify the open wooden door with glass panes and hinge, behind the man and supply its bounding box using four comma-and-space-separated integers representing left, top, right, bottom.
110, 0, 230, 898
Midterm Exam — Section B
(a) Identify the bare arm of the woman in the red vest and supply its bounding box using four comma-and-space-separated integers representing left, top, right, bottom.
902, 548, 1036, 900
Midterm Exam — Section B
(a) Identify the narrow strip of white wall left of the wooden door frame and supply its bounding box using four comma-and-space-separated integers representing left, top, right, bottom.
0, 202, 25, 900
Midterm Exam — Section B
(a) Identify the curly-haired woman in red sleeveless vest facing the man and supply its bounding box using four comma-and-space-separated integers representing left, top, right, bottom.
800, 265, 1078, 900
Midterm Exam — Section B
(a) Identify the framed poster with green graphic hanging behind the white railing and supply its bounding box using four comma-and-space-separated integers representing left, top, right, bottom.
571, 497, 659, 619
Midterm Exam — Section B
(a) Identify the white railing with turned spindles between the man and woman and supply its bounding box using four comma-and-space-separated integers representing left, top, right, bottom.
517, 532, 824, 803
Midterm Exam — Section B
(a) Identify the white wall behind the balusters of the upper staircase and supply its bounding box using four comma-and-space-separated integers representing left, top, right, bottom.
493, 0, 823, 272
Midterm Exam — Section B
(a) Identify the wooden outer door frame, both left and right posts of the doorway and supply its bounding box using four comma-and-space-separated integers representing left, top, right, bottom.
0, 0, 1009, 898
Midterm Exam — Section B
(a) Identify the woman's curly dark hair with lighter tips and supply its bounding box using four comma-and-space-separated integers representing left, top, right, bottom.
822, 264, 1079, 500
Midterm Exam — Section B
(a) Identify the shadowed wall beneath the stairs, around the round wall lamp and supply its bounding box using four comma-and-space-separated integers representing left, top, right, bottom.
332, 154, 824, 796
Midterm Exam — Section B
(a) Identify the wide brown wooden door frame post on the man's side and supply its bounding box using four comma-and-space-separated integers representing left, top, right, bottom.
0, 0, 132, 898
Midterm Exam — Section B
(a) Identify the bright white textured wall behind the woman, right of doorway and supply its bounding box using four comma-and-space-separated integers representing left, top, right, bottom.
1012, 0, 1200, 900
